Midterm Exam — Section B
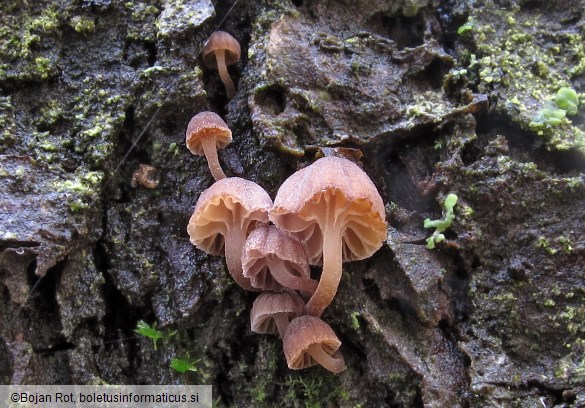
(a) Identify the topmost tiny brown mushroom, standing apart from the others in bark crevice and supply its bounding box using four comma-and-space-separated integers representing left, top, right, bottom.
201, 31, 241, 99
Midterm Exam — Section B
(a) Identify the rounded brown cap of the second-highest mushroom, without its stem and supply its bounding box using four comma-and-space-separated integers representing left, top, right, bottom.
185, 112, 232, 156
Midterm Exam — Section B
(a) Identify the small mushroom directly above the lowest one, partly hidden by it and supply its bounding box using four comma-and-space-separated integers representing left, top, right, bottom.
250, 292, 305, 337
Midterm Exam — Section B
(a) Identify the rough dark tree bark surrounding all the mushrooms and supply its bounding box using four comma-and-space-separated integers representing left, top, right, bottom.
0, 0, 585, 407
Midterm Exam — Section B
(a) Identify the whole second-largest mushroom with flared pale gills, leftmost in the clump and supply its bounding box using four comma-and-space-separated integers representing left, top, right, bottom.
187, 177, 272, 291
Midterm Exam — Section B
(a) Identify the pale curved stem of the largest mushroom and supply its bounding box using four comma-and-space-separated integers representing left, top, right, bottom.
305, 212, 343, 317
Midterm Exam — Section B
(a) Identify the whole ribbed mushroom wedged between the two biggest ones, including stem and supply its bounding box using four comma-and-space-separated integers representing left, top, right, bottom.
242, 225, 318, 296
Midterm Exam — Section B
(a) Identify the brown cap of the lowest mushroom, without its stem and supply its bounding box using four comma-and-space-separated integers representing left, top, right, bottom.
282, 316, 341, 370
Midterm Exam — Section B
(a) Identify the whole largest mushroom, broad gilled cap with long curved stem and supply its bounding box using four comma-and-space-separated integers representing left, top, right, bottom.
270, 157, 386, 316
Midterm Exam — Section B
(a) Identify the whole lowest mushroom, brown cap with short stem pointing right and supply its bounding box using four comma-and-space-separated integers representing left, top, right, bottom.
282, 316, 346, 373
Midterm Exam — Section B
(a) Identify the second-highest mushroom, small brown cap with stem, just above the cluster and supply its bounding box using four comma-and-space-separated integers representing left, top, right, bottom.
185, 112, 232, 180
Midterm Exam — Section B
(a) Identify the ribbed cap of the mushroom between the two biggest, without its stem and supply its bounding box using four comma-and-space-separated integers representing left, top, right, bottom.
242, 225, 310, 290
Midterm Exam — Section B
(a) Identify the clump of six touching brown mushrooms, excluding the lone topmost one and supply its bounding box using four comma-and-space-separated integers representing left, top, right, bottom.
186, 112, 386, 373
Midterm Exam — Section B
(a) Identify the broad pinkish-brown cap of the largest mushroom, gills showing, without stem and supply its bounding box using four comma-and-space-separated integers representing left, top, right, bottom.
270, 157, 387, 265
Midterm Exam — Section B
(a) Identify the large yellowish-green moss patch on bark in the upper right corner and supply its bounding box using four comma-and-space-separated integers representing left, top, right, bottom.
466, 6, 585, 152
